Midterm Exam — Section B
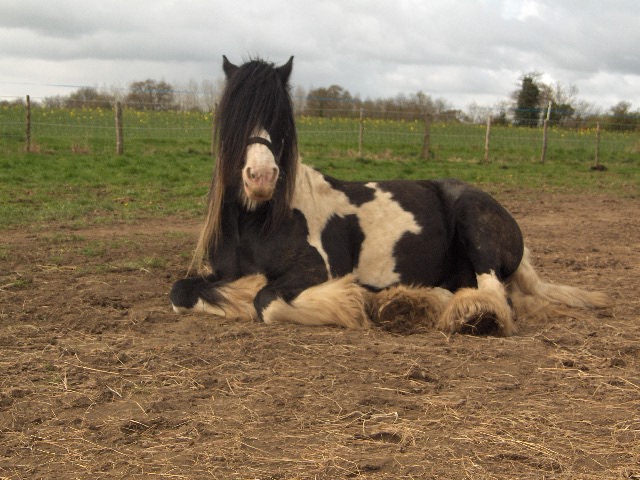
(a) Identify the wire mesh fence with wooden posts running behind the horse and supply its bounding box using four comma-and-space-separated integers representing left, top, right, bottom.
0, 98, 640, 163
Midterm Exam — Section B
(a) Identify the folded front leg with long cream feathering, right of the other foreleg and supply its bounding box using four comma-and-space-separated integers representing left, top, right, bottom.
255, 275, 371, 328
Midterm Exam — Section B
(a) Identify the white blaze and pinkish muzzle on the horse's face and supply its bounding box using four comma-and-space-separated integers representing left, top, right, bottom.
242, 130, 280, 206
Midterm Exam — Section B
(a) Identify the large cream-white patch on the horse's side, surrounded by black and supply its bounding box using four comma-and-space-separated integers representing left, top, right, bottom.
354, 182, 422, 288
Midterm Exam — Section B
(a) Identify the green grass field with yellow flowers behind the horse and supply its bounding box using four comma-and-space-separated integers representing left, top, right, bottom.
0, 106, 640, 228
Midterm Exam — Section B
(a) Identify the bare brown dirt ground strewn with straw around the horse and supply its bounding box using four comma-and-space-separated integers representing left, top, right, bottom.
0, 192, 640, 480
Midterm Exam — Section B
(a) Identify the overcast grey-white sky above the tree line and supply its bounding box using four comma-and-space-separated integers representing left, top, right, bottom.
0, 0, 640, 110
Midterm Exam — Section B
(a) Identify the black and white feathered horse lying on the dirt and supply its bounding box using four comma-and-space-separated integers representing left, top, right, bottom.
170, 56, 609, 336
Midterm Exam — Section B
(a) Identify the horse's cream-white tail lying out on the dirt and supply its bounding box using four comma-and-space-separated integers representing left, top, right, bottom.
507, 248, 611, 317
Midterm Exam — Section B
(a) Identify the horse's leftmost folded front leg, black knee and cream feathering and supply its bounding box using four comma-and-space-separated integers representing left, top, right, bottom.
169, 274, 267, 320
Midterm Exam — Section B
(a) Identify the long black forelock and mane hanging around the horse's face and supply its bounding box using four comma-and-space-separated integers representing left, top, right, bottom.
192, 60, 298, 269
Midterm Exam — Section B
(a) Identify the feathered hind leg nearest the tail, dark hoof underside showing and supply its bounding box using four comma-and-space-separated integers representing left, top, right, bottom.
438, 271, 516, 336
